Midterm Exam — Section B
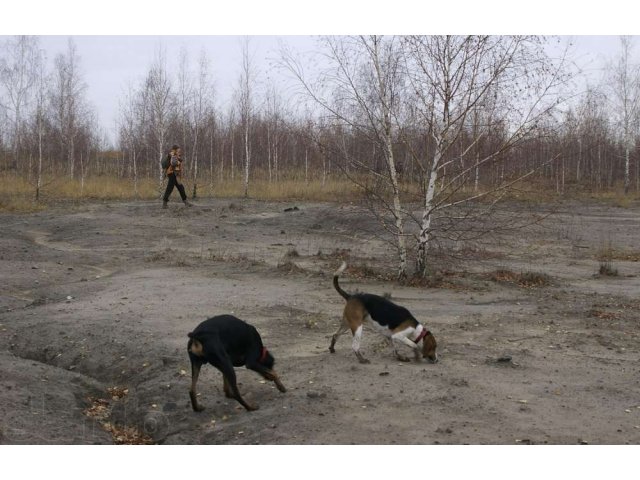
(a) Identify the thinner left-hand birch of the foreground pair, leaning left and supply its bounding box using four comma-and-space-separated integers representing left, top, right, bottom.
283, 36, 407, 278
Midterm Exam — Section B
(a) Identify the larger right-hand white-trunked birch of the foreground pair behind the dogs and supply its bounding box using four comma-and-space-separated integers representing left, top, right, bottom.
403, 36, 565, 276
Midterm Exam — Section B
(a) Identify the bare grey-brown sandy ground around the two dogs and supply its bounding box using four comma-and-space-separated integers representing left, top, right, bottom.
0, 200, 640, 444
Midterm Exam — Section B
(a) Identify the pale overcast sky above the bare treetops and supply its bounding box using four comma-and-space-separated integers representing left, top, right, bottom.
22, 35, 628, 141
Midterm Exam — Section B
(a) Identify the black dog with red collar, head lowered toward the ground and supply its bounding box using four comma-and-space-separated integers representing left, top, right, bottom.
187, 315, 287, 412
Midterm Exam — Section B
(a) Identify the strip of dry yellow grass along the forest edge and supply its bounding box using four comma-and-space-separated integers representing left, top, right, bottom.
0, 172, 640, 213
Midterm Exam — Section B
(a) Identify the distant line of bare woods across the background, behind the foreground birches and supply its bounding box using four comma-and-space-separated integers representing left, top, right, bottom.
0, 36, 640, 198
